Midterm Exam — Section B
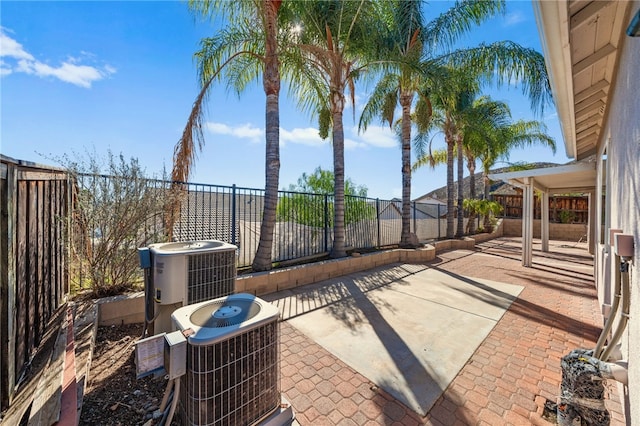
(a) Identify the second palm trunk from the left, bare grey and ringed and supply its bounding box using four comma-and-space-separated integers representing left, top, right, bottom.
329, 90, 347, 259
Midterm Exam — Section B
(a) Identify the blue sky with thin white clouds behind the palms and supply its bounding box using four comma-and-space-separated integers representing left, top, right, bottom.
0, 1, 569, 199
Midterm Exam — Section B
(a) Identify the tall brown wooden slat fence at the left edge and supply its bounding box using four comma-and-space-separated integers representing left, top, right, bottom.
0, 155, 70, 409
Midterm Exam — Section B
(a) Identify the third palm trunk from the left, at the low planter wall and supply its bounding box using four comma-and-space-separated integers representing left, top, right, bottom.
400, 93, 413, 247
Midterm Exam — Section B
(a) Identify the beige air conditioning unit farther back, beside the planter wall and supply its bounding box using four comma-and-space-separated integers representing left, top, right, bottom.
149, 240, 237, 333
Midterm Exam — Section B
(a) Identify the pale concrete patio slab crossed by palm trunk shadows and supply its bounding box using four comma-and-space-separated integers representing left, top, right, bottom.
266, 264, 523, 416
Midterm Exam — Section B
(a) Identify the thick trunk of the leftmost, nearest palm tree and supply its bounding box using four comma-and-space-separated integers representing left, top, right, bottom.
252, 0, 280, 271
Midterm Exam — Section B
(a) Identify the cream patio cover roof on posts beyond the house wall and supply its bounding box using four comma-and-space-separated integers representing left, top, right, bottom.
489, 162, 596, 194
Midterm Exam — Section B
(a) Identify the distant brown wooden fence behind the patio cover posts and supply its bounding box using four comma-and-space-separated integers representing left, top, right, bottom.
493, 194, 589, 223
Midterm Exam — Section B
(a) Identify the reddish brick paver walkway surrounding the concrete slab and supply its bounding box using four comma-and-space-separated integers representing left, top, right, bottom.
282, 238, 625, 426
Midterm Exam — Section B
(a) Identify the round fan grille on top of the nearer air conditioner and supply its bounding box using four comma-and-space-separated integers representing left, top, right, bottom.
189, 299, 260, 328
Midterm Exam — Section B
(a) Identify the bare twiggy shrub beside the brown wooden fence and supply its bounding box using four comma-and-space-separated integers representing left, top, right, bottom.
60, 151, 171, 297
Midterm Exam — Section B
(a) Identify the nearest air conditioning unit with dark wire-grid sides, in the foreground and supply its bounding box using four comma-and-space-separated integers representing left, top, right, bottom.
171, 293, 293, 425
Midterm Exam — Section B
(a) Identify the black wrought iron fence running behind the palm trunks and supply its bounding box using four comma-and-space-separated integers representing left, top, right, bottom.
71, 175, 468, 280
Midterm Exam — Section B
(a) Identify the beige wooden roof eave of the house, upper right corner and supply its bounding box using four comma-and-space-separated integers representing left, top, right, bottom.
533, 0, 632, 160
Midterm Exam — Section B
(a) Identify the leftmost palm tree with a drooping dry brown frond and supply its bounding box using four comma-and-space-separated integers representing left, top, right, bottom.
172, 0, 287, 271
